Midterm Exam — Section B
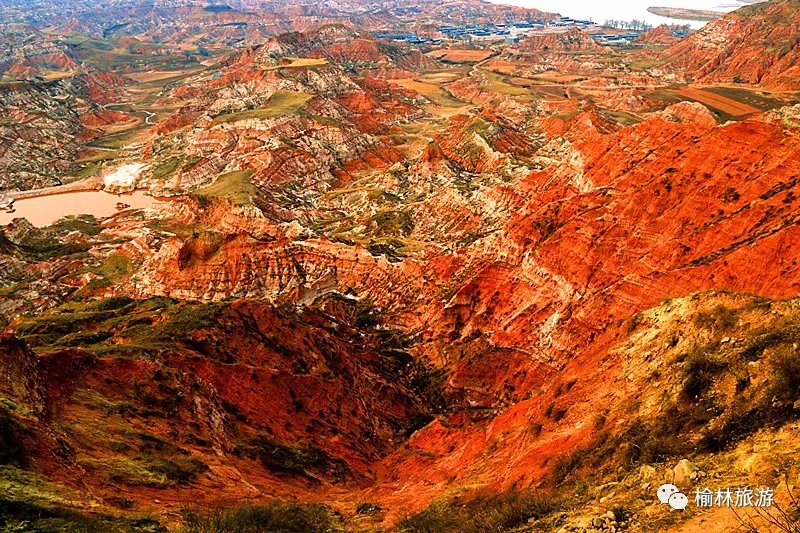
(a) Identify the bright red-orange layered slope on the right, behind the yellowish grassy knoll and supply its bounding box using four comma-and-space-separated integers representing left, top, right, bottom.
346, 101, 800, 516
